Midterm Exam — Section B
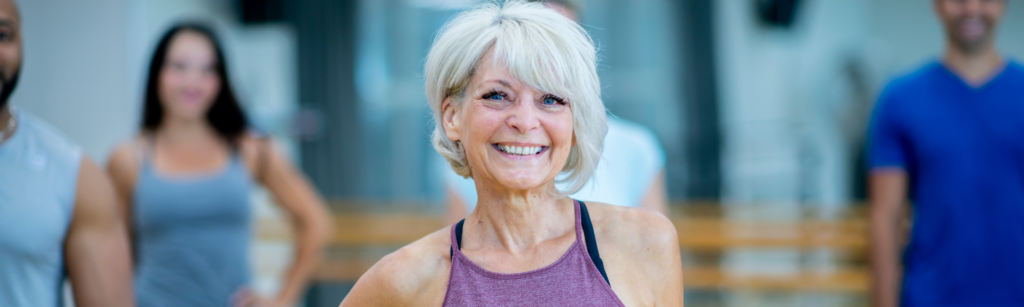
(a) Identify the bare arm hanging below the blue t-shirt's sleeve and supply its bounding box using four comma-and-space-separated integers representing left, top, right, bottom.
869, 169, 907, 307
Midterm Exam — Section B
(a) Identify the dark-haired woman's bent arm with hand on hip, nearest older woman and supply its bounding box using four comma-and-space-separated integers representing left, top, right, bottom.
259, 141, 333, 305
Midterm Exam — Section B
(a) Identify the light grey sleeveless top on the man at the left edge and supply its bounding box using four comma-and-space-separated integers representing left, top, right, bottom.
0, 108, 82, 307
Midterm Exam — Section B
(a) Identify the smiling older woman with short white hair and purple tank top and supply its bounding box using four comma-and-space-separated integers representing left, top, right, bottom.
341, 1, 683, 306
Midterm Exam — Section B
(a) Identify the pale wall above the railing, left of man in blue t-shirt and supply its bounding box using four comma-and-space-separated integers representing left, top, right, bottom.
714, 0, 866, 204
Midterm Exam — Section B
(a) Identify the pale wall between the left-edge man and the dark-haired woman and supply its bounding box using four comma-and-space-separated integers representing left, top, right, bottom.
11, 0, 136, 162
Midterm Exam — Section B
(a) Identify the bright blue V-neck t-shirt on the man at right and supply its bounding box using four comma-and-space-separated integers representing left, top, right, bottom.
869, 61, 1024, 306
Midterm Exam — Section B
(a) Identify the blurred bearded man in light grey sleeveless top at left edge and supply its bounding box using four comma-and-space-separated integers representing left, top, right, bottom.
0, 0, 134, 307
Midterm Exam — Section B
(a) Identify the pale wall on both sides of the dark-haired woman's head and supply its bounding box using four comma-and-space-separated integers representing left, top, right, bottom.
11, 0, 298, 164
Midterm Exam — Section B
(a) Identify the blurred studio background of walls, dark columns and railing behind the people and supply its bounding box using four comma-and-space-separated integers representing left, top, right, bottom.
11, 0, 1024, 306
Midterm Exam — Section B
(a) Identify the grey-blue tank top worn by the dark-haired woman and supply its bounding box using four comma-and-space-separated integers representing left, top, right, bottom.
132, 145, 252, 307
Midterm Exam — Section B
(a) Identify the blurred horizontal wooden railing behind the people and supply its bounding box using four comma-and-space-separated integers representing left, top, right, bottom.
257, 205, 868, 293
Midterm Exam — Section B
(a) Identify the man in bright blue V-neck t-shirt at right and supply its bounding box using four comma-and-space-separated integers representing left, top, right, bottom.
868, 0, 1024, 306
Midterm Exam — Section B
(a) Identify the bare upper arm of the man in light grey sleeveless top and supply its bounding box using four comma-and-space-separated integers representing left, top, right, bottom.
65, 158, 135, 307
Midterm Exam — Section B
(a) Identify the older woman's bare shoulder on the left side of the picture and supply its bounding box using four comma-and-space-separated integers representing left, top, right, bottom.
341, 224, 452, 306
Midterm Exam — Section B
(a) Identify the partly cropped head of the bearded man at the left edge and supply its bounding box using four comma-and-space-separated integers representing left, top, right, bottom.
0, 0, 22, 107
